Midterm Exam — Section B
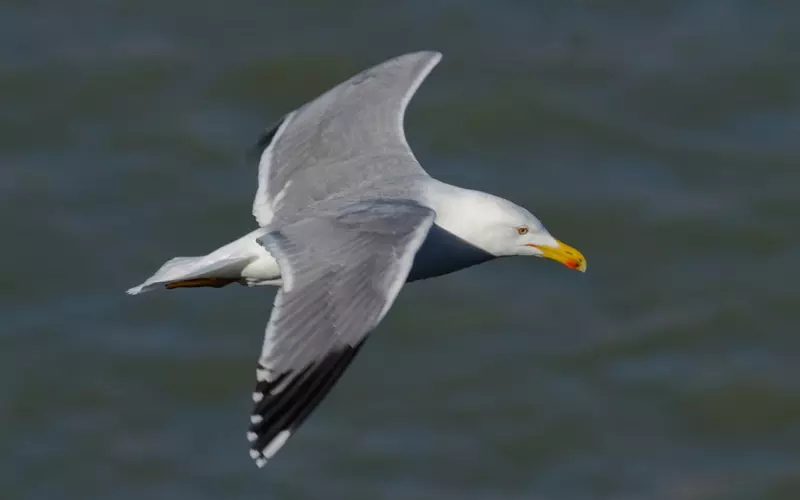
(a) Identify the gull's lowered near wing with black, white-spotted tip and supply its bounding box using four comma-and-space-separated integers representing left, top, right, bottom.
248, 200, 435, 467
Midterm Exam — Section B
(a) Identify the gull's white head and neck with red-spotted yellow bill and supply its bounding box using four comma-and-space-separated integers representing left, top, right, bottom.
424, 184, 586, 272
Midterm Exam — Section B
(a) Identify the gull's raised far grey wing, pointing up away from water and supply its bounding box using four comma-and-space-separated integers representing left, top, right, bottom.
253, 52, 442, 226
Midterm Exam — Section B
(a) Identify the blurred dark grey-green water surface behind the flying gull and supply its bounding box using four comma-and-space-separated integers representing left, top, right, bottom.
0, 0, 800, 500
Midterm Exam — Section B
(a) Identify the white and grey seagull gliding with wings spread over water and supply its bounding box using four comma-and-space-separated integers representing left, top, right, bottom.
127, 51, 586, 467
